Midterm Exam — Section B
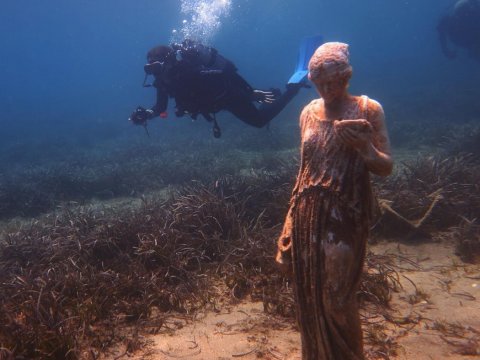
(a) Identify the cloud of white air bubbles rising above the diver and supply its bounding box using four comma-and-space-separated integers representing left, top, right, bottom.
172, 0, 232, 43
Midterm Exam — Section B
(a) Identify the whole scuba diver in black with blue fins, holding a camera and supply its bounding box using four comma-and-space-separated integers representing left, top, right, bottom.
129, 36, 320, 138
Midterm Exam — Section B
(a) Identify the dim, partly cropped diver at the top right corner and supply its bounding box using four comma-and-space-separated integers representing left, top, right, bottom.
437, 0, 480, 61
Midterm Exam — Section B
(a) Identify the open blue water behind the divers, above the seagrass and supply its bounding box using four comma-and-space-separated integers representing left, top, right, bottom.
0, 0, 480, 151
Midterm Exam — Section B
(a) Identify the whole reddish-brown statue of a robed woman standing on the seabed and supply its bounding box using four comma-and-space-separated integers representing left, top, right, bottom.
276, 43, 393, 360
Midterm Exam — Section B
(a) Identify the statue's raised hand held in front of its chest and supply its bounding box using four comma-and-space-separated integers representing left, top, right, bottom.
333, 119, 373, 151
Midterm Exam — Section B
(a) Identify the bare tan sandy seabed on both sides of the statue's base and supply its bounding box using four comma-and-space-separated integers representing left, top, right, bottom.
106, 236, 480, 360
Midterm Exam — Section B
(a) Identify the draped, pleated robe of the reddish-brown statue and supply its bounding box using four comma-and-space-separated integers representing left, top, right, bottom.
279, 96, 372, 360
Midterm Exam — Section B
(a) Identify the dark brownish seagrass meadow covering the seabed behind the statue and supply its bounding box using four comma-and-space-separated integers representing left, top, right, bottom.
0, 118, 480, 359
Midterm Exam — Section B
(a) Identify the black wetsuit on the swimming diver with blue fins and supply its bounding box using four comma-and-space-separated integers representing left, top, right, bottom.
149, 41, 301, 127
